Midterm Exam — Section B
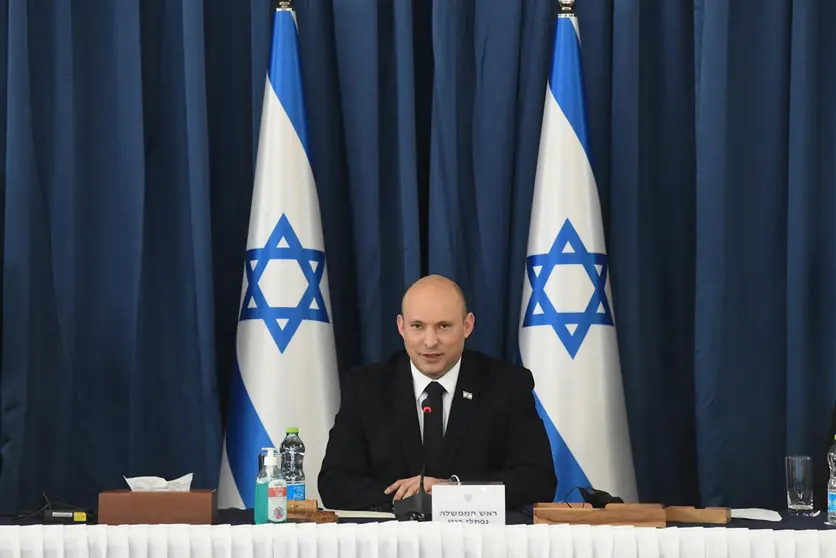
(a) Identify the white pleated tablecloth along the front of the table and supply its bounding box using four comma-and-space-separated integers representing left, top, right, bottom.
0, 522, 836, 558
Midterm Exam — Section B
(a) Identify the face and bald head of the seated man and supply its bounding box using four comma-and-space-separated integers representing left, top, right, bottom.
398, 284, 474, 379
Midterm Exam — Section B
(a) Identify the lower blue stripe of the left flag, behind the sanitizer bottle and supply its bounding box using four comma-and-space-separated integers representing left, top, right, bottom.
226, 358, 275, 509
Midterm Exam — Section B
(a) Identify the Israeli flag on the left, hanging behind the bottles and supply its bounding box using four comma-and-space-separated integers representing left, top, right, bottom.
218, 5, 339, 508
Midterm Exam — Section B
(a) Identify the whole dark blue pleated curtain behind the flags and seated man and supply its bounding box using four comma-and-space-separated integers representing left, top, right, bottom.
0, 0, 836, 512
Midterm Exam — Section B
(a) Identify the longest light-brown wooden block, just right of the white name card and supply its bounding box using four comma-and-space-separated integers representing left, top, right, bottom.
534, 503, 666, 527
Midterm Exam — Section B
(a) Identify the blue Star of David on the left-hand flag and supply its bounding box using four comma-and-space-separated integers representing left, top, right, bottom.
240, 214, 328, 353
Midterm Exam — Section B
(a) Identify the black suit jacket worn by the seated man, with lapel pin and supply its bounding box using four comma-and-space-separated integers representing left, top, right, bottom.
319, 350, 557, 510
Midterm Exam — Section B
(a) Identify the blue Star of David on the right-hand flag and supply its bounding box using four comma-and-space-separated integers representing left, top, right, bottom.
523, 219, 614, 359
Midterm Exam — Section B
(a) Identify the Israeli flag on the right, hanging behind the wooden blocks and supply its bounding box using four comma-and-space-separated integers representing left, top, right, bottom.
519, 14, 637, 502
